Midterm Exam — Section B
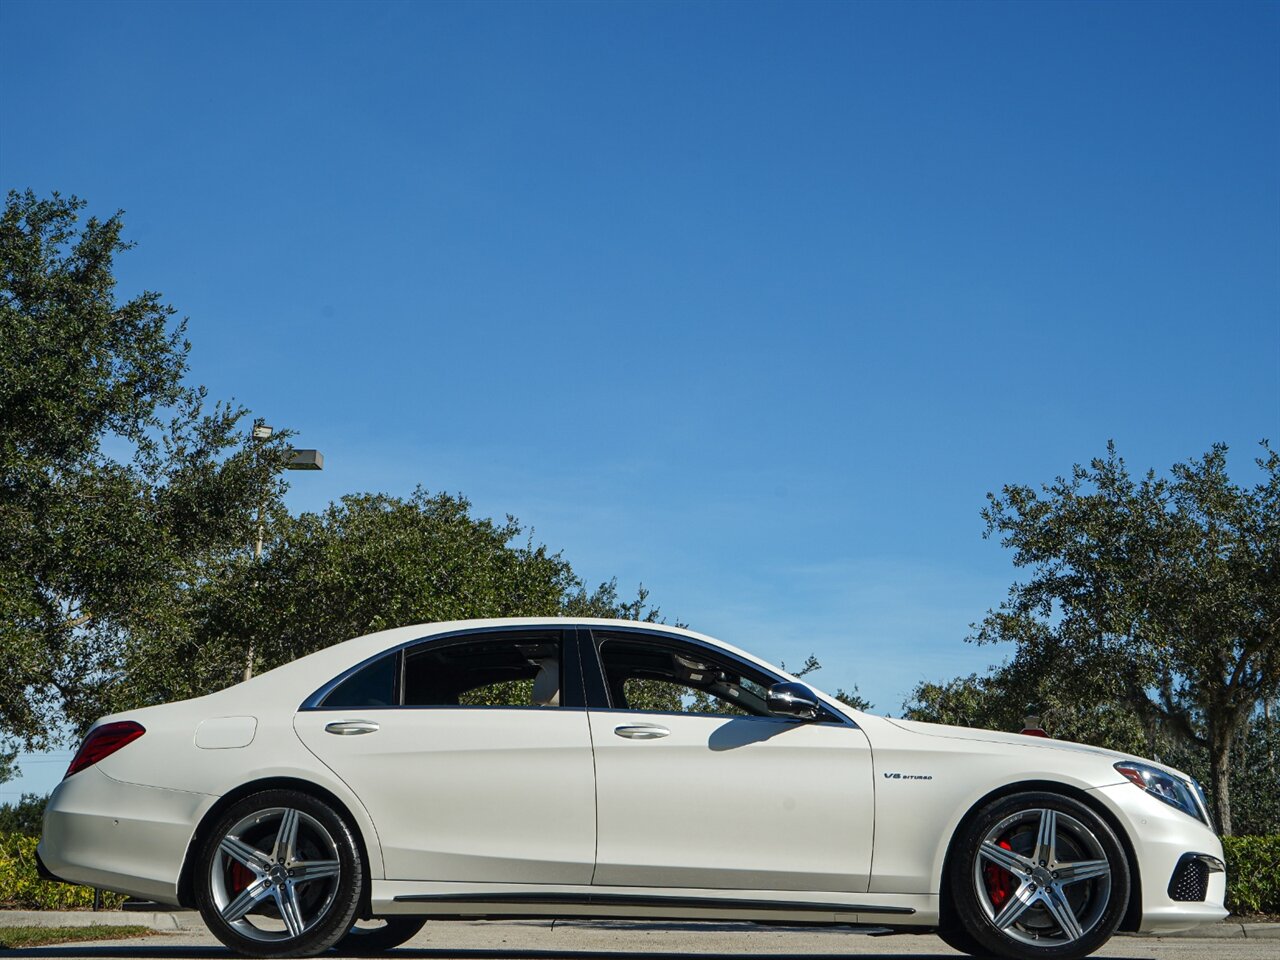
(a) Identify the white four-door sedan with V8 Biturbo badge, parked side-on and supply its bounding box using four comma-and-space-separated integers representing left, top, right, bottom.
38, 618, 1226, 960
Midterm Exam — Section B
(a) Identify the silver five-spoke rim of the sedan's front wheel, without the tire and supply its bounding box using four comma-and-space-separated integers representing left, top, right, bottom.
973, 809, 1111, 947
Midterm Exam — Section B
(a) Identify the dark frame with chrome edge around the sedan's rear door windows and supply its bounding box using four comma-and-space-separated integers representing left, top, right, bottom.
298, 623, 586, 713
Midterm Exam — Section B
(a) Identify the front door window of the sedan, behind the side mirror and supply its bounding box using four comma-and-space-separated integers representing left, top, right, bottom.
599, 635, 773, 717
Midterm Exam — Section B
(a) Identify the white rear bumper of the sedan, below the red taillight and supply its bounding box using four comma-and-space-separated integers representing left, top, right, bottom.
36, 767, 214, 905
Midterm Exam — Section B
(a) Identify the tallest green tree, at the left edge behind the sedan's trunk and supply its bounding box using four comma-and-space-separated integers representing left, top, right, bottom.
0, 191, 284, 749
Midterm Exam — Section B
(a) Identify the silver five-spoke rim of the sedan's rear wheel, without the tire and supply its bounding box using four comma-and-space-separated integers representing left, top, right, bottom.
209, 806, 342, 941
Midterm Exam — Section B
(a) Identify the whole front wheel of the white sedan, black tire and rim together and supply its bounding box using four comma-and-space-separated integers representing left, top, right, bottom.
947, 792, 1129, 960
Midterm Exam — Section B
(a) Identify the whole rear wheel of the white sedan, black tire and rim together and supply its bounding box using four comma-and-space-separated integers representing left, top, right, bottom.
195, 790, 365, 960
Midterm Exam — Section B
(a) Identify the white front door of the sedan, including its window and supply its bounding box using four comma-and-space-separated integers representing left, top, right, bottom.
582, 631, 874, 892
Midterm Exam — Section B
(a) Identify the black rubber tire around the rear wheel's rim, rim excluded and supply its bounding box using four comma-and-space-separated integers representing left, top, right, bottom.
195, 790, 365, 957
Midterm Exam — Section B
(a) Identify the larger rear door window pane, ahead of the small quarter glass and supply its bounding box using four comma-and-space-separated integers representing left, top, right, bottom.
404, 634, 563, 707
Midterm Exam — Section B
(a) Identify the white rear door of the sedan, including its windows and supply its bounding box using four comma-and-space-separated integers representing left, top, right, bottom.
294, 628, 595, 883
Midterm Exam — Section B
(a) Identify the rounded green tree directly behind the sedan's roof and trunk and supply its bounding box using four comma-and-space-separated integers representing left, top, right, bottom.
111, 489, 660, 705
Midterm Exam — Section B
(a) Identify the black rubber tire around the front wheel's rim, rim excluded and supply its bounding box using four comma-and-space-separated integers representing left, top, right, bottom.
947, 792, 1129, 960
